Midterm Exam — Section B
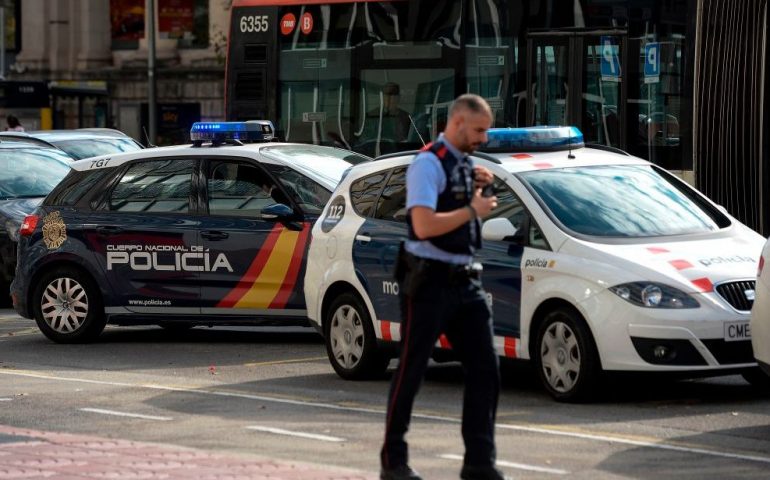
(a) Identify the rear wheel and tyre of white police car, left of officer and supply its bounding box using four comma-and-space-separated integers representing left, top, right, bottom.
324, 293, 389, 380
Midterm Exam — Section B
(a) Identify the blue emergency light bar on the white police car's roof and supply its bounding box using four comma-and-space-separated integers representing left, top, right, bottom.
479, 126, 585, 152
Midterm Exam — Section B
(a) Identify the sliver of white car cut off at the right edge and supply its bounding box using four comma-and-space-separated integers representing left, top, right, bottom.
750, 239, 770, 383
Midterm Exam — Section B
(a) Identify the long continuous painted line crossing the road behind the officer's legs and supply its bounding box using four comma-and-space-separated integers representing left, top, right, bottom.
0, 369, 770, 464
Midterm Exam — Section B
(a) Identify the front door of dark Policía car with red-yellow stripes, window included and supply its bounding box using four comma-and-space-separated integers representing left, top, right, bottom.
201, 159, 309, 324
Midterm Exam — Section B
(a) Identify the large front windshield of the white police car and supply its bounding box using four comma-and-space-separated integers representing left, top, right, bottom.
520, 165, 730, 238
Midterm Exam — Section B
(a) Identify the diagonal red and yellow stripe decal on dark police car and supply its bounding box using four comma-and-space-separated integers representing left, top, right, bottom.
217, 223, 310, 308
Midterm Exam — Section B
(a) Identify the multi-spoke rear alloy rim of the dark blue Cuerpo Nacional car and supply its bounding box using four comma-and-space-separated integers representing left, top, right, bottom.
40, 278, 88, 334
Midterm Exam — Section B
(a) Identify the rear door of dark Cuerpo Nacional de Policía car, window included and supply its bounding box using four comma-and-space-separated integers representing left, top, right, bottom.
89, 158, 201, 315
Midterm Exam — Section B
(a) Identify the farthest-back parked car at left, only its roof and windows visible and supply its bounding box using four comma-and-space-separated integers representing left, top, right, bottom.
0, 128, 144, 160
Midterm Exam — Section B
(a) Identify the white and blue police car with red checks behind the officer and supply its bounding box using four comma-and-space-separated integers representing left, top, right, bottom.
305, 127, 763, 400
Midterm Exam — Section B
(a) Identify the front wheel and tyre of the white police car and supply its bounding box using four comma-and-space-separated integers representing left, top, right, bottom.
532, 308, 601, 402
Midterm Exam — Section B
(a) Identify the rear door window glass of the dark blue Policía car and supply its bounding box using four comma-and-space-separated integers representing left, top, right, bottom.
107, 159, 195, 213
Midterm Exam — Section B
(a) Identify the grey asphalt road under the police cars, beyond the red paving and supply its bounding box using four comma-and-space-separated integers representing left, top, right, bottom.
0, 310, 770, 479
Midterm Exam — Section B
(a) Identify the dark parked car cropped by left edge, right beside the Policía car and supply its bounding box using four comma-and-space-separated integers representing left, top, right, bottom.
0, 141, 72, 304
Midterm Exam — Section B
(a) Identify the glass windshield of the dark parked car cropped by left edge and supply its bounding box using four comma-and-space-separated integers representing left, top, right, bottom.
0, 148, 71, 200
